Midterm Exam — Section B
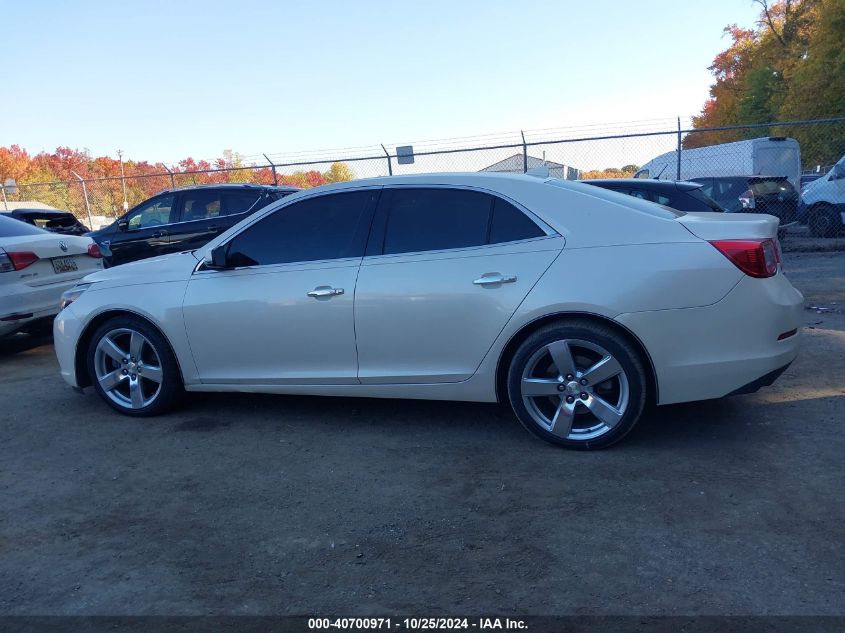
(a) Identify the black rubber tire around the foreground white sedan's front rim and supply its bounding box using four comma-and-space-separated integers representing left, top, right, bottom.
86, 315, 184, 417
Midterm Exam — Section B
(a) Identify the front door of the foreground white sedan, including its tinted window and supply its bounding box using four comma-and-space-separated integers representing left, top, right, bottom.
183, 189, 379, 385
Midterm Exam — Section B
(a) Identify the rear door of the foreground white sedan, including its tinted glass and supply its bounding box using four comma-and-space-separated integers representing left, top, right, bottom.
355, 187, 563, 384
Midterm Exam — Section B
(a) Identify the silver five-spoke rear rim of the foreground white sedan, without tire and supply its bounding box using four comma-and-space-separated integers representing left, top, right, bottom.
520, 339, 629, 440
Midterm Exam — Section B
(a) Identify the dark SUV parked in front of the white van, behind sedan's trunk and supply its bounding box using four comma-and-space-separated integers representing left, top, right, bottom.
693, 176, 800, 227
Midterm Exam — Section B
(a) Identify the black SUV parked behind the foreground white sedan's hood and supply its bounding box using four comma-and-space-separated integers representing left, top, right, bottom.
88, 184, 299, 266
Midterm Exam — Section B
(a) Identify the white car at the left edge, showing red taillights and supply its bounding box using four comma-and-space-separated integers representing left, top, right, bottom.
0, 217, 103, 337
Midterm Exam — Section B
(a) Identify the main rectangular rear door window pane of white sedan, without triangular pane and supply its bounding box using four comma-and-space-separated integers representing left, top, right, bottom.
383, 189, 493, 254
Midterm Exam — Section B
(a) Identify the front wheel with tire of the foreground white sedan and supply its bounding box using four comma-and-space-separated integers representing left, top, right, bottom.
87, 316, 182, 417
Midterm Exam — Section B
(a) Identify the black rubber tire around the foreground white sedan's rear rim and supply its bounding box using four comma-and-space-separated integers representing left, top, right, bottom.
507, 319, 647, 450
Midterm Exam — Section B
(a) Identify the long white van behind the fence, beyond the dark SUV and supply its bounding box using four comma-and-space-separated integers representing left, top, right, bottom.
634, 136, 801, 191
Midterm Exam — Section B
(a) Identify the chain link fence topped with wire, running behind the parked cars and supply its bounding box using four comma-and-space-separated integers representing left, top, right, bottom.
4, 117, 845, 232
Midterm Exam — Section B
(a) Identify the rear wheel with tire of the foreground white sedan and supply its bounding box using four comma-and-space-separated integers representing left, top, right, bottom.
508, 320, 646, 449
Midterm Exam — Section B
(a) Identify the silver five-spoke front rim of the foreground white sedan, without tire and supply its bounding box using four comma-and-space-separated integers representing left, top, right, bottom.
94, 328, 164, 409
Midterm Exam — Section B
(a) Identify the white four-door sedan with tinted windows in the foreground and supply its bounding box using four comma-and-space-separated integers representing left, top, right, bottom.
54, 174, 803, 449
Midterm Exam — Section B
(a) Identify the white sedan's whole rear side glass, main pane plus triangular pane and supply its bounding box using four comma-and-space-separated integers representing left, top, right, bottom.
378, 188, 545, 255
